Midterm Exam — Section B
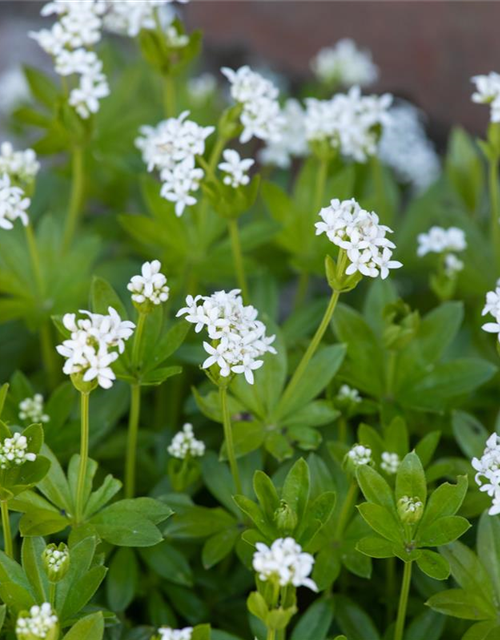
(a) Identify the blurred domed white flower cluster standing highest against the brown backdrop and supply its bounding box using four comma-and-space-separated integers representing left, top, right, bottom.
311, 38, 378, 87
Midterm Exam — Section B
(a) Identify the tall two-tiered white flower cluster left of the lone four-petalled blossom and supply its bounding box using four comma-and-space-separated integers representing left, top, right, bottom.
135, 111, 214, 216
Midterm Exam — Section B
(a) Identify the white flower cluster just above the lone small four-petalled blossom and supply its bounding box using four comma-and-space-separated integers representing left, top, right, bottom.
221, 66, 283, 143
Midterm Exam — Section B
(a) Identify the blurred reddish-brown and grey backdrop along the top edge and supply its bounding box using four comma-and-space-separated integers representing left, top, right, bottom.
0, 0, 500, 144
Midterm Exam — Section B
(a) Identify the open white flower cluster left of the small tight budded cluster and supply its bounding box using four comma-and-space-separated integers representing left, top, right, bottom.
57, 307, 135, 389
